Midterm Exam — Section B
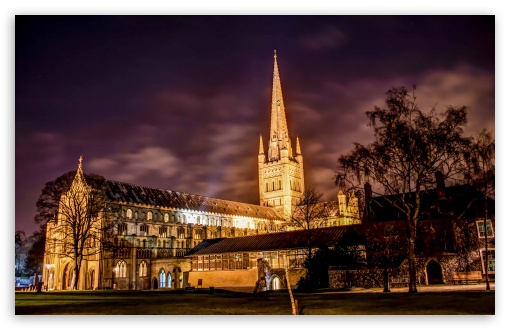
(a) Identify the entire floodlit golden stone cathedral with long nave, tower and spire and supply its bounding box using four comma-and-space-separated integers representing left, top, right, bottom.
42, 52, 361, 292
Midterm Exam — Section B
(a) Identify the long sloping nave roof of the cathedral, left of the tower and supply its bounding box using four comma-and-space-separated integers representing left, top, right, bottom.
99, 180, 283, 220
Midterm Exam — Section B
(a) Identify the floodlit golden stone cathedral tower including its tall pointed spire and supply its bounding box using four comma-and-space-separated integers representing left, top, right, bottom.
258, 51, 305, 219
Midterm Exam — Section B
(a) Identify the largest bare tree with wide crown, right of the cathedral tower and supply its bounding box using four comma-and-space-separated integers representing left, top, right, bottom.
336, 87, 469, 292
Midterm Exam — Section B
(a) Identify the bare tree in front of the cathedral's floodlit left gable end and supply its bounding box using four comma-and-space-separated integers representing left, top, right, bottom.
39, 164, 116, 289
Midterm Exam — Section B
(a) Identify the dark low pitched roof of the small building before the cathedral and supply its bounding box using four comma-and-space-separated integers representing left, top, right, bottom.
186, 225, 363, 257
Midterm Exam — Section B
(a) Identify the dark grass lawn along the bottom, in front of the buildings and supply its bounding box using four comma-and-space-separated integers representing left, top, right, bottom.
15, 290, 495, 315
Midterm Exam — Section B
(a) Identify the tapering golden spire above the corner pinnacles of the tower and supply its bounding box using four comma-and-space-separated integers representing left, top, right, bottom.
268, 50, 293, 160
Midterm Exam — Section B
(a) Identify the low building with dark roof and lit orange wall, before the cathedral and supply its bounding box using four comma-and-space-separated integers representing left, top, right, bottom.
186, 225, 364, 292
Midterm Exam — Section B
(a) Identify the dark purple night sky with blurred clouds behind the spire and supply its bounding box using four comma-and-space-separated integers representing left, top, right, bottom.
14, 15, 495, 235
